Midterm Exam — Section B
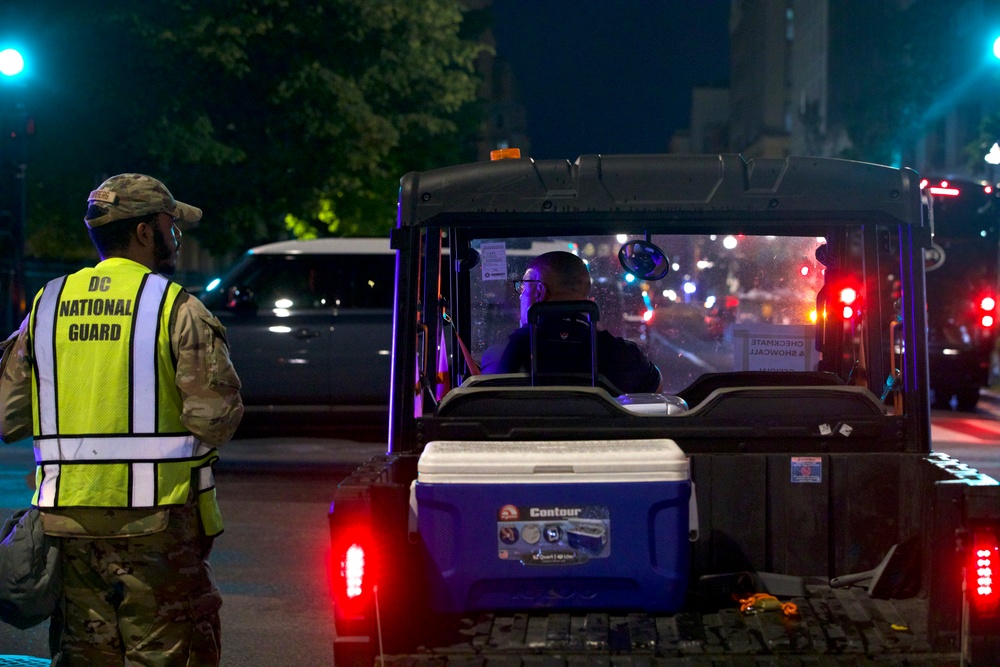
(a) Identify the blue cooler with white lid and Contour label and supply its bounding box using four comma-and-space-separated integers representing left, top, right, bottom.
411, 439, 691, 613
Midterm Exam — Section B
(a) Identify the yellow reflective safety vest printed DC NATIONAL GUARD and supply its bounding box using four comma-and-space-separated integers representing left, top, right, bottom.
29, 258, 222, 535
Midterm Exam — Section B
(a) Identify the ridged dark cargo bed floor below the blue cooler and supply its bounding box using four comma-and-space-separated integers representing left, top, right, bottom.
385, 585, 959, 666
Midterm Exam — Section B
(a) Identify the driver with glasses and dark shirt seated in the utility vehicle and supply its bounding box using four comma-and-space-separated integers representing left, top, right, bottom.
482, 251, 663, 394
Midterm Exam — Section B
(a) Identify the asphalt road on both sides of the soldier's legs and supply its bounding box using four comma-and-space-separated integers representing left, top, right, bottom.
0, 438, 385, 667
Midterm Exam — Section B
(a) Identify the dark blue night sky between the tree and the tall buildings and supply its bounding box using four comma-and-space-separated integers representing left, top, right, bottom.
493, 0, 730, 160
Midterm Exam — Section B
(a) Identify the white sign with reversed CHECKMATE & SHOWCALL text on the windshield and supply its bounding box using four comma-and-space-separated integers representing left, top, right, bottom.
733, 324, 818, 371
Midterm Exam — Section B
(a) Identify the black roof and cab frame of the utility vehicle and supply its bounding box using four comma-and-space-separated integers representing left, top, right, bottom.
389, 155, 930, 460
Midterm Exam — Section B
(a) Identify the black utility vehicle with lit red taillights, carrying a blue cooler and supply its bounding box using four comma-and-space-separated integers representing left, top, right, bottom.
330, 154, 1000, 666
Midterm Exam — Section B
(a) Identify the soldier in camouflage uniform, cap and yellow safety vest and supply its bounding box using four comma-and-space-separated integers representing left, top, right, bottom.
0, 174, 243, 666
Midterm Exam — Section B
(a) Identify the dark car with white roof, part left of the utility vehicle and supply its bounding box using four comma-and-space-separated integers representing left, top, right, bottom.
199, 238, 395, 428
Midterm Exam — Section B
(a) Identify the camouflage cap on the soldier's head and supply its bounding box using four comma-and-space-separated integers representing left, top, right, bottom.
83, 174, 201, 228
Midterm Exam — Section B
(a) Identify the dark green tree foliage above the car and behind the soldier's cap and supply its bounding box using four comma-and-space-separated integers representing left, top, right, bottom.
14, 0, 488, 256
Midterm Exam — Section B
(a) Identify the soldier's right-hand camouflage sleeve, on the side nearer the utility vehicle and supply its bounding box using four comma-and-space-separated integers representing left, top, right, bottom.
171, 293, 243, 445
